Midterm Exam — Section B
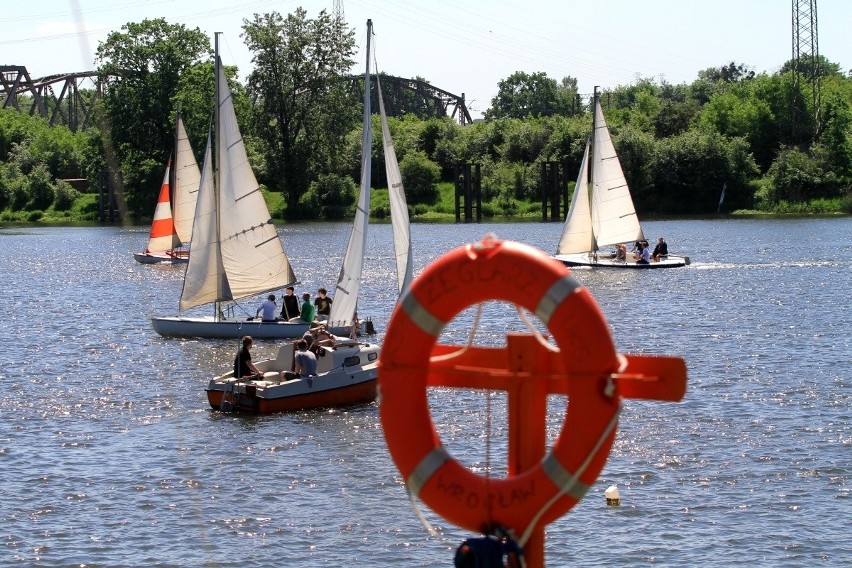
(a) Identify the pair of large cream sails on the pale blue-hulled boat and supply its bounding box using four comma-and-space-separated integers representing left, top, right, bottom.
180, 51, 296, 310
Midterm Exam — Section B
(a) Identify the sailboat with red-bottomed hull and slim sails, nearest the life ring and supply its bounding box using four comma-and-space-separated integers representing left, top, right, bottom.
207, 20, 413, 414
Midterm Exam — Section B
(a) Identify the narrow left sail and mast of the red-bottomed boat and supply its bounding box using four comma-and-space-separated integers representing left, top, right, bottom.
328, 20, 373, 325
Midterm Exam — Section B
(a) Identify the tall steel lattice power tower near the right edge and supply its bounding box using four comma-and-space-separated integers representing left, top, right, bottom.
792, 0, 820, 141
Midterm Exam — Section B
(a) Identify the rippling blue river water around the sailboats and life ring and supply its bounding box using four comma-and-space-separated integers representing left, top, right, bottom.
0, 217, 852, 566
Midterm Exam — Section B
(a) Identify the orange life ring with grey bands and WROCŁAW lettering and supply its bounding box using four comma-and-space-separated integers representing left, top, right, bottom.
379, 239, 621, 532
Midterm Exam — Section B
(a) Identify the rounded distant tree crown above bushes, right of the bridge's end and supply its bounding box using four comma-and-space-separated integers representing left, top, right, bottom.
485, 71, 571, 119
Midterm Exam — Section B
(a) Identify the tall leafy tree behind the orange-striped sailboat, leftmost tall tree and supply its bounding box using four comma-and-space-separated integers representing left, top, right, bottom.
96, 18, 210, 215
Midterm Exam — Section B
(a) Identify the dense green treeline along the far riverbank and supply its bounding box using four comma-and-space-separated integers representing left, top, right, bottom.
0, 9, 852, 224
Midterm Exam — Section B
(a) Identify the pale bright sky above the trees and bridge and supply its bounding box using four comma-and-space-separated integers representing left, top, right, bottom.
0, 0, 852, 118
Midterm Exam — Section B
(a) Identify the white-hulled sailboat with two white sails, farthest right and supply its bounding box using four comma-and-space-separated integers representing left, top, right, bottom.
554, 87, 690, 269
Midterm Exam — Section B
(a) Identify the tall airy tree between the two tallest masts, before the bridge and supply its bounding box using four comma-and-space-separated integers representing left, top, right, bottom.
243, 8, 360, 212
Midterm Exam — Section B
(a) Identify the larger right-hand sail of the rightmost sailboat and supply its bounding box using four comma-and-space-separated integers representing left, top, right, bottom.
591, 99, 645, 249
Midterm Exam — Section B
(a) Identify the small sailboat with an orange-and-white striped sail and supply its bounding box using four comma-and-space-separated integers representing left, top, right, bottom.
133, 113, 201, 264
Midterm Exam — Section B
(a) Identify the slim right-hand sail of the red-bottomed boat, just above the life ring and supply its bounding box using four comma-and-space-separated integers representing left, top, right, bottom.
376, 75, 414, 294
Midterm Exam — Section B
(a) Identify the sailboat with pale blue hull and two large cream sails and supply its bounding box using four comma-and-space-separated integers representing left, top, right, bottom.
151, 35, 312, 338
